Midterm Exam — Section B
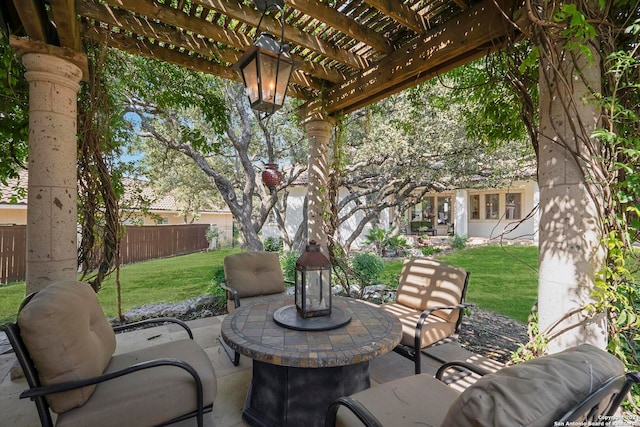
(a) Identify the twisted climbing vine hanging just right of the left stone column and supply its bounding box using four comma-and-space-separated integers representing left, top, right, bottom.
78, 45, 123, 317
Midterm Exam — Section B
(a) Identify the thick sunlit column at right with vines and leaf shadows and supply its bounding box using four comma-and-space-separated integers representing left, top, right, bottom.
538, 41, 607, 352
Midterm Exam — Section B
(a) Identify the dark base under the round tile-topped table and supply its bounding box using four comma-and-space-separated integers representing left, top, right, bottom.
242, 360, 370, 427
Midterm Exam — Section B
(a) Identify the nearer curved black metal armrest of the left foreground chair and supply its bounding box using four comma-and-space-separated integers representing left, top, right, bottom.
20, 359, 204, 426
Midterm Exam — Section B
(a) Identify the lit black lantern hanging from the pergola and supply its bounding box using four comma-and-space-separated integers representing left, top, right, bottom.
233, 0, 296, 116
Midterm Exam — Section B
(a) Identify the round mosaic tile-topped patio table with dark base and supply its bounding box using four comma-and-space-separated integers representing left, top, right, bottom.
222, 297, 402, 427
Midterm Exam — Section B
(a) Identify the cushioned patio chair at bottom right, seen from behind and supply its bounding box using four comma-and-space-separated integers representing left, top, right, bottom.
325, 344, 640, 427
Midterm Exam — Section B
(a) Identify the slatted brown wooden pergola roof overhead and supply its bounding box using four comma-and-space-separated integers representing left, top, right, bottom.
0, 0, 526, 114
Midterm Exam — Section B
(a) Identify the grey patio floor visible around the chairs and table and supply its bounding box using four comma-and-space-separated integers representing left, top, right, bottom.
0, 316, 502, 427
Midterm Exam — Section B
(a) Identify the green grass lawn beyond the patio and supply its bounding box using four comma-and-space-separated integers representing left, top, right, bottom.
0, 246, 538, 324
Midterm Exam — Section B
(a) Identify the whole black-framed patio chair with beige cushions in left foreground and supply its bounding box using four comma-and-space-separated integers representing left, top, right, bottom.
4, 280, 217, 427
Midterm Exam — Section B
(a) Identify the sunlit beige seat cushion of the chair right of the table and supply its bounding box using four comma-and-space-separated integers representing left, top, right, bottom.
380, 302, 456, 348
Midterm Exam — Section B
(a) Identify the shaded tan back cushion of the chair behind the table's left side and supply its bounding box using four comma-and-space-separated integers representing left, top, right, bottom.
224, 252, 284, 298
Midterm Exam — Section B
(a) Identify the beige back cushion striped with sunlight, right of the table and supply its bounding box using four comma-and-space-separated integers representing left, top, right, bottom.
396, 258, 466, 323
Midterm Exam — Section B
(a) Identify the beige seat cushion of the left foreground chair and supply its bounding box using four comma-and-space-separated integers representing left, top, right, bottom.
56, 339, 217, 427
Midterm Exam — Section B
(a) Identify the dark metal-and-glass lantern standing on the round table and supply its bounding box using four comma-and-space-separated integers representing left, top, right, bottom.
295, 240, 331, 319
